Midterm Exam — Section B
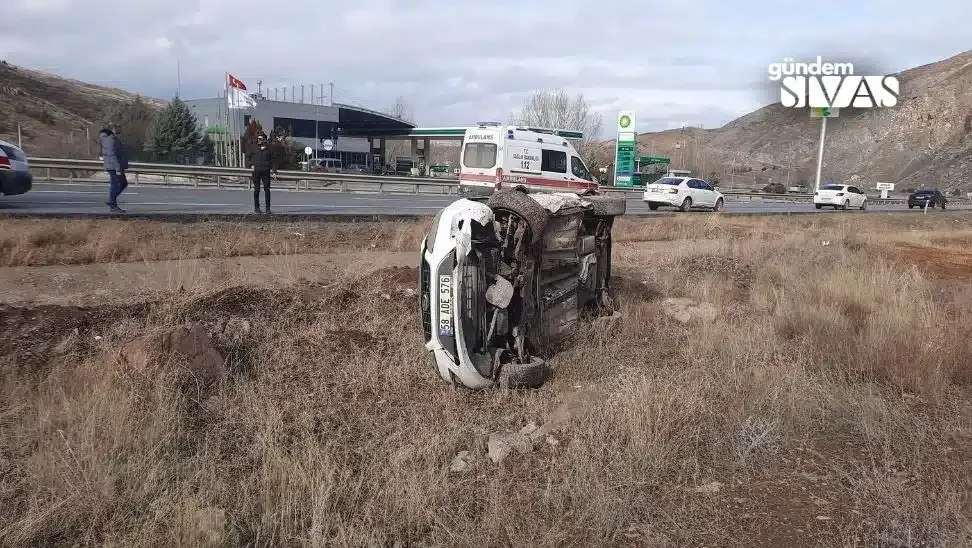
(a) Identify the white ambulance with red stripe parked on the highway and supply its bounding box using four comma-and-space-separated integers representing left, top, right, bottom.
459, 122, 598, 196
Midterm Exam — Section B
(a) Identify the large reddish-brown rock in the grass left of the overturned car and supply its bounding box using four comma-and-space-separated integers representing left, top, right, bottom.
119, 323, 225, 384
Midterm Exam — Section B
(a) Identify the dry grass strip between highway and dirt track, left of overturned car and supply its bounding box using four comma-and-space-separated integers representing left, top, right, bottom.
0, 218, 426, 266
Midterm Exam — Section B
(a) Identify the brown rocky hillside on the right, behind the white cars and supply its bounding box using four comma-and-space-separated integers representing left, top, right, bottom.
604, 51, 972, 193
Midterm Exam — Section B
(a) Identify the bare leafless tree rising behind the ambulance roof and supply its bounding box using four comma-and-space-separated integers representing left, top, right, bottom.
510, 90, 601, 164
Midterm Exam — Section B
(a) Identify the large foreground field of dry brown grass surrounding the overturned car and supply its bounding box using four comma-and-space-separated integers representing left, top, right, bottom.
0, 212, 972, 546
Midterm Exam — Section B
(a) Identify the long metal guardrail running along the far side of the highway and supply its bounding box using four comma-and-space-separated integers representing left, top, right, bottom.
24, 158, 972, 208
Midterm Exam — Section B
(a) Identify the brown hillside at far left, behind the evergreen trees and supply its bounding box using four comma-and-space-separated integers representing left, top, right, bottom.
0, 62, 164, 158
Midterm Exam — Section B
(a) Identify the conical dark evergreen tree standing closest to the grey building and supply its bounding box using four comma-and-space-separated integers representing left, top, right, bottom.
145, 98, 207, 164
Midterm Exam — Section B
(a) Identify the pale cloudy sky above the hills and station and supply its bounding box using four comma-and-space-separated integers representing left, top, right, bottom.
0, 0, 972, 133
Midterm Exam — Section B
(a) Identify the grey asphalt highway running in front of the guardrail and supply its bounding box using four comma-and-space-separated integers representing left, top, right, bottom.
0, 184, 944, 215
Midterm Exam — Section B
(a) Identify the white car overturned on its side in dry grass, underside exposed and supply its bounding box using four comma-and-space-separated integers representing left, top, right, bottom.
419, 189, 625, 389
